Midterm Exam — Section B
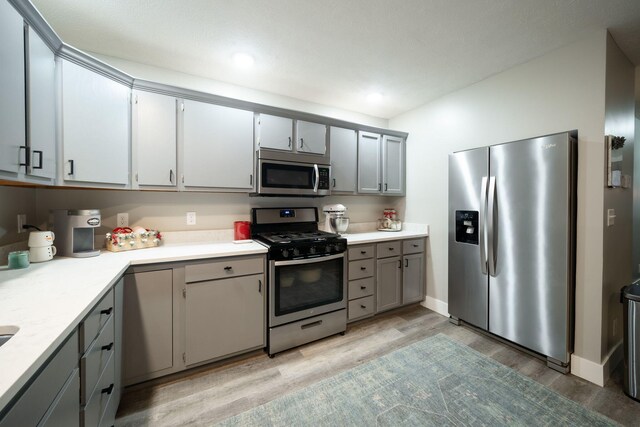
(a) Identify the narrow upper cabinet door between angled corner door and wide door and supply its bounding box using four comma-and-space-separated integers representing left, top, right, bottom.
131, 90, 177, 187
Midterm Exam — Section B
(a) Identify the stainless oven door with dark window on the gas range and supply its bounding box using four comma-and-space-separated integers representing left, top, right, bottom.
269, 253, 347, 327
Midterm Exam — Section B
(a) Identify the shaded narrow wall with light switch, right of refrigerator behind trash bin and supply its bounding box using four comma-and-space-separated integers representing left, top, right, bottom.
601, 35, 637, 357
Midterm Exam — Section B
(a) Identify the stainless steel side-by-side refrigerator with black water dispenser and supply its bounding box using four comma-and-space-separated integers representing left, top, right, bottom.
448, 131, 577, 372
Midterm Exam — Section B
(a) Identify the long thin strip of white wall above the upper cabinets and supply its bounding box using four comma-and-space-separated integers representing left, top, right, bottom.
91, 53, 389, 128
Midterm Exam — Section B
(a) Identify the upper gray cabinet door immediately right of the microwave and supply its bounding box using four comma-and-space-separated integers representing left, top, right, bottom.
329, 127, 358, 193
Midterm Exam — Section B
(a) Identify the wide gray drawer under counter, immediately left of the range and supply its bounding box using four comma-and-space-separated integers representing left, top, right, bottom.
184, 258, 264, 283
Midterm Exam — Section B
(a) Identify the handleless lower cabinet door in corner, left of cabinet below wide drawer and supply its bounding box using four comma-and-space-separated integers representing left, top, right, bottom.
122, 270, 173, 385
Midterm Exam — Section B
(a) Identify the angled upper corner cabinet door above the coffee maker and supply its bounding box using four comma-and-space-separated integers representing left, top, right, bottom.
62, 61, 130, 184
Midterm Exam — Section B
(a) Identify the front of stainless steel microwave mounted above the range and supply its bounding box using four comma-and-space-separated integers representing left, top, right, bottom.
258, 159, 331, 196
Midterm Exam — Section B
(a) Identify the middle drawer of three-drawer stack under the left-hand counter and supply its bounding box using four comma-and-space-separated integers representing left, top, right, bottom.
80, 317, 115, 405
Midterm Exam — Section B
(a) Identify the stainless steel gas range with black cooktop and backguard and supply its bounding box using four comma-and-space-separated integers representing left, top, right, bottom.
251, 208, 347, 357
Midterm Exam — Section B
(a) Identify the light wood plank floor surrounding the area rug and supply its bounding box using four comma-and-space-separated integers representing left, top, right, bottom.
116, 305, 640, 426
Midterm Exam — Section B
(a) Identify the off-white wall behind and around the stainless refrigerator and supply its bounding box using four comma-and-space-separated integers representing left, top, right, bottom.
390, 30, 607, 363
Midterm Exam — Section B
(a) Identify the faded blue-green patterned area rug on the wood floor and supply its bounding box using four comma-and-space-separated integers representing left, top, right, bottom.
219, 334, 617, 426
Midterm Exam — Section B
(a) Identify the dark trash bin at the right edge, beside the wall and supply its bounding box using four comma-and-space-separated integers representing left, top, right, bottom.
621, 283, 640, 400
